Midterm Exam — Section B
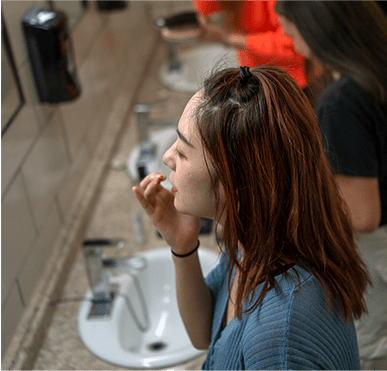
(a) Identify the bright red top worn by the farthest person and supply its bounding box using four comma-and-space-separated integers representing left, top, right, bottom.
193, 0, 306, 88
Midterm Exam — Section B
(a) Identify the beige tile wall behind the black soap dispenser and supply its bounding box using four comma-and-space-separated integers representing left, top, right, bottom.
1, 0, 156, 355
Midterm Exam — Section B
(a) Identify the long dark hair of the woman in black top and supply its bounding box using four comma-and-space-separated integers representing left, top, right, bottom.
275, 0, 387, 103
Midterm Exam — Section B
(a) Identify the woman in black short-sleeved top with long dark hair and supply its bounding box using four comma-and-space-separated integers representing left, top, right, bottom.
276, 1, 387, 369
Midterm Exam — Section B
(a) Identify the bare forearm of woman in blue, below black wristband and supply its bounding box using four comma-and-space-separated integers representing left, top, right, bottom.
173, 251, 212, 349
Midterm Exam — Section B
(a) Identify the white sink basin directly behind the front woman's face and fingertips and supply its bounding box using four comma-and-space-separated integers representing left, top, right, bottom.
127, 127, 177, 191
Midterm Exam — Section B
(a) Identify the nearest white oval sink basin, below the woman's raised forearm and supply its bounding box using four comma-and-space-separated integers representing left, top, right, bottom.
78, 248, 219, 369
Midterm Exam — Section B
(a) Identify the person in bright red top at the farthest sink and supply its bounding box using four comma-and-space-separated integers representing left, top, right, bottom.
193, 0, 307, 88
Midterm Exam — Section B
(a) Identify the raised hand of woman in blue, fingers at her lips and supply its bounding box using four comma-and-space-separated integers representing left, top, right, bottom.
132, 173, 200, 254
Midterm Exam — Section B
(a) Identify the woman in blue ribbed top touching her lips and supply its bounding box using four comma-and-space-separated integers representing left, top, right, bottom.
133, 66, 368, 371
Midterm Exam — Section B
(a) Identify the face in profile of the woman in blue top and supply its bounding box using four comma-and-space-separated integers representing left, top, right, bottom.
163, 91, 222, 219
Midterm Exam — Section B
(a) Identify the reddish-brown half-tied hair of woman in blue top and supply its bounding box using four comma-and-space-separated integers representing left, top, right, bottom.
196, 66, 369, 320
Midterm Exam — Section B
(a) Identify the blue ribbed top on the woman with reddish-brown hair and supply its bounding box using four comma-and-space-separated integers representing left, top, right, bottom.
202, 255, 360, 371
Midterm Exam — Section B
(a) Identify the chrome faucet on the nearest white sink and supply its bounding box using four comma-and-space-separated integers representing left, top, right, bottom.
82, 239, 125, 318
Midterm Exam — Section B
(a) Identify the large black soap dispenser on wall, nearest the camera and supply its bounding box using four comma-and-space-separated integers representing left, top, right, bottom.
22, 7, 81, 103
